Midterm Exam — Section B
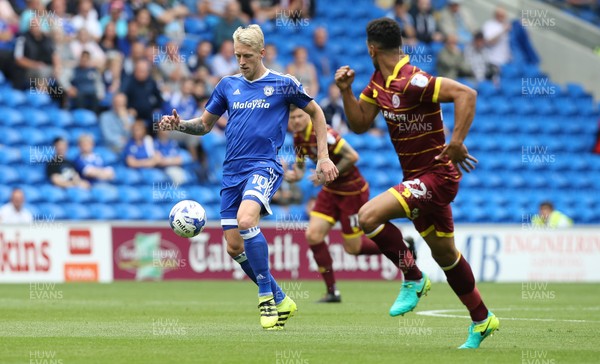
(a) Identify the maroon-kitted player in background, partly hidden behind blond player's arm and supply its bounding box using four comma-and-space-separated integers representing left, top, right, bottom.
284, 105, 381, 303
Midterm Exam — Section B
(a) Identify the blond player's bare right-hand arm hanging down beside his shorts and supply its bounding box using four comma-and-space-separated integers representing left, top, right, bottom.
303, 100, 338, 184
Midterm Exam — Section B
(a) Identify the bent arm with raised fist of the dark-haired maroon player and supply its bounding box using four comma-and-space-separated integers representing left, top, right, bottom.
335, 66, 379, 134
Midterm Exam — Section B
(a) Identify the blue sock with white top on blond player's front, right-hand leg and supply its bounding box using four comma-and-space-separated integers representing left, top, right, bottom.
240, 226, 285, 303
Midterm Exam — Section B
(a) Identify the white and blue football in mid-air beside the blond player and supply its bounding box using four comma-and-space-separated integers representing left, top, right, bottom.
169, 200, 206, 238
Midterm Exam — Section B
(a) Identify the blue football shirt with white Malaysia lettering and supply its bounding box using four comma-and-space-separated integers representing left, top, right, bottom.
206, 70, 312, 185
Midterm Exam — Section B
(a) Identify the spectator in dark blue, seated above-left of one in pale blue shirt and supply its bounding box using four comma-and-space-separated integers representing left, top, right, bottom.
68, 51, 104, 112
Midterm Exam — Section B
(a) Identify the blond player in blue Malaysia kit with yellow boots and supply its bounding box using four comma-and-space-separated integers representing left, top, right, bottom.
159, 24, 338, 330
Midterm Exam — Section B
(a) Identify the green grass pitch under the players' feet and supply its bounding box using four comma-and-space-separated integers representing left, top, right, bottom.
0, 281, 600, 364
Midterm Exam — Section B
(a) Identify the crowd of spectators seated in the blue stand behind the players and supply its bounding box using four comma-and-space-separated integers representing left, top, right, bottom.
0, 0, 592, 223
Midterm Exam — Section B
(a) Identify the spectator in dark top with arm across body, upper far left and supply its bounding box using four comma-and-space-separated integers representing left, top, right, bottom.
15, 16, 60, 91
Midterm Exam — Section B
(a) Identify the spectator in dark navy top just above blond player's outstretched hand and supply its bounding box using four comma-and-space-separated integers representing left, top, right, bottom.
122, 59, 163, 126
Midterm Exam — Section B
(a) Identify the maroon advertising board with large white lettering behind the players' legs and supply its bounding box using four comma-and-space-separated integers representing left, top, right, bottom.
112, 227, 398, 280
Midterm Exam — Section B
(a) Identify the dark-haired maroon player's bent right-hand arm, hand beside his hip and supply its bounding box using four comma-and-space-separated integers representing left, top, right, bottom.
436, 78, 478, 173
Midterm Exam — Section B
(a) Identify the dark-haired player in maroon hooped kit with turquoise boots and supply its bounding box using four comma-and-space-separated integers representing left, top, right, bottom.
335, 18, 499, 348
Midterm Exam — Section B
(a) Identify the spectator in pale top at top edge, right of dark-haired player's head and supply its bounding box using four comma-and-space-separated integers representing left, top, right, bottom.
439, 0, 476, 45
